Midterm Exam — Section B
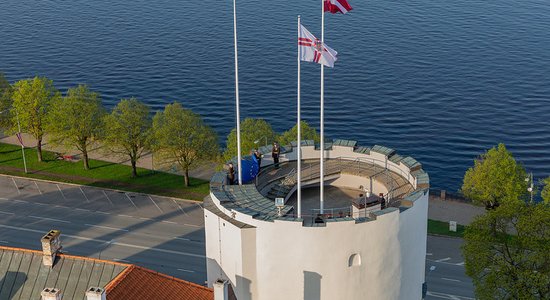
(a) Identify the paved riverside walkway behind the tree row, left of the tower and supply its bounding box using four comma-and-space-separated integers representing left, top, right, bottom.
0, 131, 216, 181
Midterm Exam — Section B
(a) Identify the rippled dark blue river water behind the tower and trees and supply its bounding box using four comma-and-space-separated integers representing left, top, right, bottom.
0, 0, 550, 190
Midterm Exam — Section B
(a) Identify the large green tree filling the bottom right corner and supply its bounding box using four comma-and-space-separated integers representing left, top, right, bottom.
462, 202, 550, 299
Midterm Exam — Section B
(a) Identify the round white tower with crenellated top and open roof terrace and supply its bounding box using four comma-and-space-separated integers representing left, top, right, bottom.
205, 140, 429, 300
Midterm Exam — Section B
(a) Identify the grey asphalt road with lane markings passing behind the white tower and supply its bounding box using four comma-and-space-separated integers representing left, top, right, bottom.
0, 176, 474, 300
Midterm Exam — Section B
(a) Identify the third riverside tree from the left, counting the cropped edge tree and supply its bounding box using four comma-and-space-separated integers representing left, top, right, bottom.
46, 85, 105, 170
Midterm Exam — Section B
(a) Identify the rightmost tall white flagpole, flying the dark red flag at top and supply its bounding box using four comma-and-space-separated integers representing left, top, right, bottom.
319, 0, 325, 214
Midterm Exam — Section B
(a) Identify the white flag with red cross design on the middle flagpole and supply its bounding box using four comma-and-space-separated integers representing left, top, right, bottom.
298, 25, 338, 68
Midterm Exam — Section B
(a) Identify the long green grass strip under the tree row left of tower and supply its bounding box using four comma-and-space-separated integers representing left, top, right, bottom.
0, 143, 209, 200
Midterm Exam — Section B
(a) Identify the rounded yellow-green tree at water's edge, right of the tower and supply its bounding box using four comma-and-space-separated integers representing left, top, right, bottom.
462, 144, 527, 209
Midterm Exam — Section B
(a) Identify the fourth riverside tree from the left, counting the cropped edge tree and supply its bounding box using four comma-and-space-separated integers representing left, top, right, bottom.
104, 98, 152, 177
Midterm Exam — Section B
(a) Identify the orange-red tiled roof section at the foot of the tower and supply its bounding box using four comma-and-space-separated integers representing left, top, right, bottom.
105, 265, 214, 300
